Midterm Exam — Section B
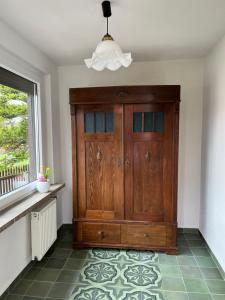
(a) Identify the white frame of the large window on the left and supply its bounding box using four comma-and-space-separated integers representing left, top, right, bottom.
0, 64, 43, 212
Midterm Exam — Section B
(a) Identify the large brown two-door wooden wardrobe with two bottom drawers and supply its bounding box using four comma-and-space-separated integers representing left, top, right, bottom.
70, 85, 180, 254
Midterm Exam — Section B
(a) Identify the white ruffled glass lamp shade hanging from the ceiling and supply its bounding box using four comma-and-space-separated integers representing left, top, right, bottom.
84, 40, 132, 71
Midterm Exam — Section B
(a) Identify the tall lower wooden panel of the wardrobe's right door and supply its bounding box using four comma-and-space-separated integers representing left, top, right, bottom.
133, 141, 163, 217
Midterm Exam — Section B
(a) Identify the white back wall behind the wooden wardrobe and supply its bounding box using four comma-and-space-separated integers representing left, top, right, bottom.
59, 60, 203, 228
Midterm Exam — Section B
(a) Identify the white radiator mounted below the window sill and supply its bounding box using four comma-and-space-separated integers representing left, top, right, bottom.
31, 198, 57, 260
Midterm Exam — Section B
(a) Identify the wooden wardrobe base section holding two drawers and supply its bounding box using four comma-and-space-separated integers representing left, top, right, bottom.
73, 220, 178, 254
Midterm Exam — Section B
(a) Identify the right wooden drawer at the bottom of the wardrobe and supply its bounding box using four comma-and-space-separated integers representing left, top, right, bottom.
121, 225, 166, 247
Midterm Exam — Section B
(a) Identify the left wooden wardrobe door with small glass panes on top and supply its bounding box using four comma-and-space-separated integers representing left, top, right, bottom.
76, 105, 124, 220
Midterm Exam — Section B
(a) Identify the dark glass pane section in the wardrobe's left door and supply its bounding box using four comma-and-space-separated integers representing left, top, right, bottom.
84, 111, 114, 133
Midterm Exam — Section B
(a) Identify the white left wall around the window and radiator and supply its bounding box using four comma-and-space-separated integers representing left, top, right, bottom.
0, 21, 62, 295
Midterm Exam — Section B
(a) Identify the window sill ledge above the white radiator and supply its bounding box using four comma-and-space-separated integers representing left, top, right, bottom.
0, 184, 65, 232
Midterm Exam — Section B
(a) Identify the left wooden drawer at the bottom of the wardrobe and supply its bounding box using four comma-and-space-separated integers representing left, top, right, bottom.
82, 223, 120, 244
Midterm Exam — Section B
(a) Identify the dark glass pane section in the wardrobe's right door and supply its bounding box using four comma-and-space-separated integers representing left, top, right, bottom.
133, 111, 164, 132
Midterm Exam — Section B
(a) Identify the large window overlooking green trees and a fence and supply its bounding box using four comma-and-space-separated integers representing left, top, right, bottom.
0, 68, 39, 196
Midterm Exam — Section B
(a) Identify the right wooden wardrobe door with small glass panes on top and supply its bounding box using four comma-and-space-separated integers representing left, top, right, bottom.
124, 104, 173, 222
